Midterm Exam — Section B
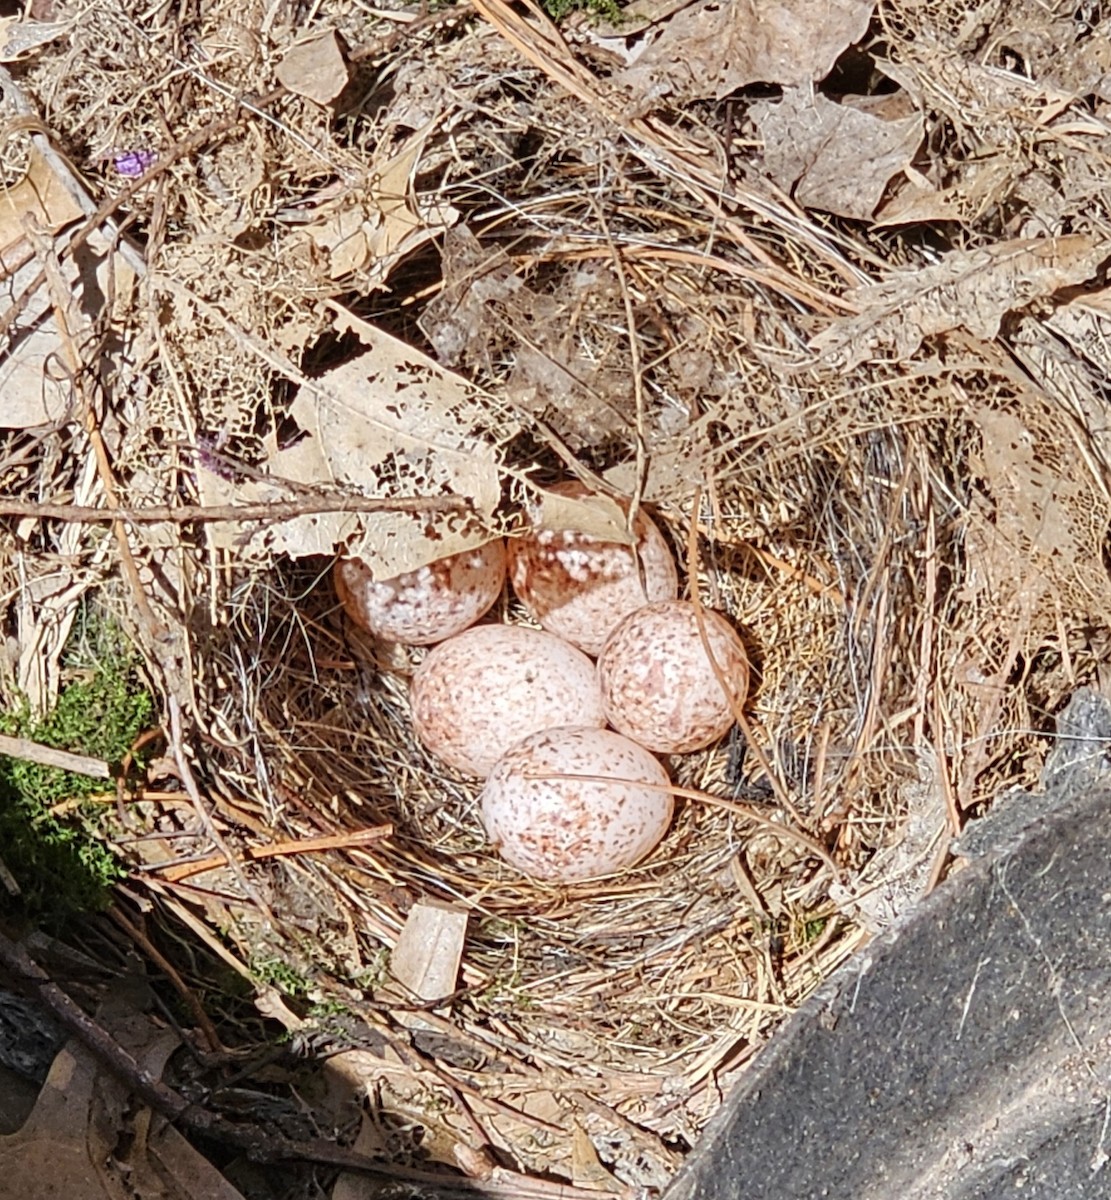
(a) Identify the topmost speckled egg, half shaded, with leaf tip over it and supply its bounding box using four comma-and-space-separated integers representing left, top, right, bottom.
509, 481, 679, 654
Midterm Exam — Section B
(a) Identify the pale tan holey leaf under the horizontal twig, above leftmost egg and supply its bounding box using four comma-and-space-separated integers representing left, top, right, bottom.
199, 307, 516, 577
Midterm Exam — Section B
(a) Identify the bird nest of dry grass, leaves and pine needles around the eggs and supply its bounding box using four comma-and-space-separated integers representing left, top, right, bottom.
0, 0, 1111, 1196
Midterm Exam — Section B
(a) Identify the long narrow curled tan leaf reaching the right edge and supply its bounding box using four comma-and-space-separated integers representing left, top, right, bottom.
810, 234, 1109, 368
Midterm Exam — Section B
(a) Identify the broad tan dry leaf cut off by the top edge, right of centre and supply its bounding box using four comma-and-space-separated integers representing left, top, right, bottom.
617, 0, 875, 102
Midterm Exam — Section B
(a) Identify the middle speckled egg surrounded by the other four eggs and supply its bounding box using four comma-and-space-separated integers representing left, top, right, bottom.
409, 625, 606, 776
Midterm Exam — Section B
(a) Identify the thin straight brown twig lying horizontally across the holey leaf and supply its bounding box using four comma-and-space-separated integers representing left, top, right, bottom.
0, 496, 470, 524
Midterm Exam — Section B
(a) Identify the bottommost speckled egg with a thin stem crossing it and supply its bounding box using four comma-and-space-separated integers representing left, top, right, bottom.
482, 728, 673, 882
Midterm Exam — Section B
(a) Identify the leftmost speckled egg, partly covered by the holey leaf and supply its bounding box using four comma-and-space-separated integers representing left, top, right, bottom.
334, 538, 505, 646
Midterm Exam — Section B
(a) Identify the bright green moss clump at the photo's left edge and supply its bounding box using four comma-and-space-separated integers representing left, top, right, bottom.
0, 610, 155, 923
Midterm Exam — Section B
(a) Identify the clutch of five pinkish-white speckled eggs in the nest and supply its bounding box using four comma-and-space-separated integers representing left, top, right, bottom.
334, 492, 749, 882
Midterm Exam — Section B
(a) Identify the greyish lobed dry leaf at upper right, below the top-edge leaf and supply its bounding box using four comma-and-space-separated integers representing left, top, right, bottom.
751, 88, 923, 220
